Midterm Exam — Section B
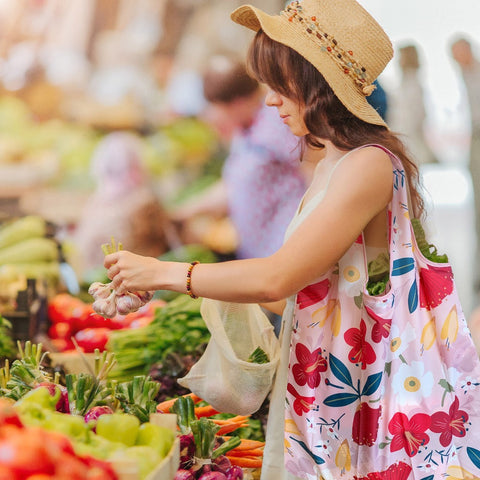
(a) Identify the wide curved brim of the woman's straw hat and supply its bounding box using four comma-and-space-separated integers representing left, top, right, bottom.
231, 5, 388, 128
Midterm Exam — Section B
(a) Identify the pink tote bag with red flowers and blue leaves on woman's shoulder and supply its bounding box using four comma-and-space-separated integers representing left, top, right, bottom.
284, 147, 480, 480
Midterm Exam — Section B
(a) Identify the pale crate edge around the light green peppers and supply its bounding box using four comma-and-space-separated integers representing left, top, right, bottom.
112, 413, 180, 480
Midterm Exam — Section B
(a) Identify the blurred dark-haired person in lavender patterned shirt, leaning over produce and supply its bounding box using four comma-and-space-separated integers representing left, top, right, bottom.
174, 55, 307, 258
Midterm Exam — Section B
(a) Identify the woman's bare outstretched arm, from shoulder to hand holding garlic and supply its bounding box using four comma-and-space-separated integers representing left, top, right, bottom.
105, 147, 393, 303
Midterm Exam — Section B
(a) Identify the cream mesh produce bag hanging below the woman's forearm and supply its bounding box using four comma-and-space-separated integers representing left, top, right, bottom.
178, 299, 280, 415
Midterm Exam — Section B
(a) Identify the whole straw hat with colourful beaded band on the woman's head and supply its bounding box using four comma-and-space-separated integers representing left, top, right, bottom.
231, 0, 393, 126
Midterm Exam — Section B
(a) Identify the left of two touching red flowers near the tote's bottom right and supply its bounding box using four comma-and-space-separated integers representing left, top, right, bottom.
388, 412, 431, 457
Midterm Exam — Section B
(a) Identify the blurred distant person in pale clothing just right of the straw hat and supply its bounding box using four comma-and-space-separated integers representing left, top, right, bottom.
389, 44, 437, 165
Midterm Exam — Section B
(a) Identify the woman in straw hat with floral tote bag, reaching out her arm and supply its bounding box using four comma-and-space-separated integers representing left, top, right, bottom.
105, 0, 480, 480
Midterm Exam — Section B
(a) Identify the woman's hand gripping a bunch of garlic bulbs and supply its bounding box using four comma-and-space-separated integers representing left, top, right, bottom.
104, 250, 168, 295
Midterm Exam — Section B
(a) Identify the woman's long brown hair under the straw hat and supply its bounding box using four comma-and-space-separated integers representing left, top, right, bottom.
247, 30, 424, 218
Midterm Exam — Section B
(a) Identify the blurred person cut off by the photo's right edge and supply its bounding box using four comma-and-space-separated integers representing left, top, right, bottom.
451, 37, 480, 296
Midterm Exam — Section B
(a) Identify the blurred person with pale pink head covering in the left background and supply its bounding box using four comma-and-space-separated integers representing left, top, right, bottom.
74, 132, 170, 271
